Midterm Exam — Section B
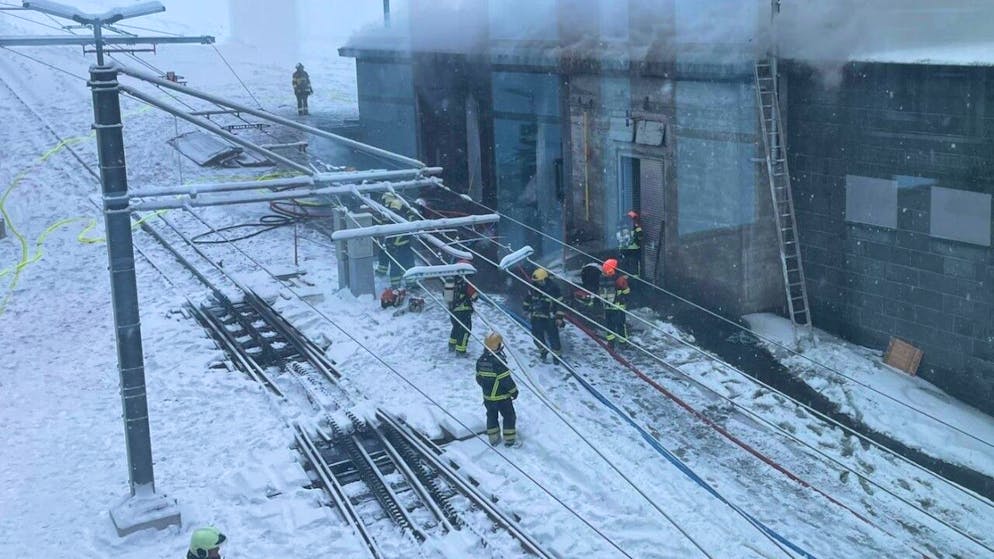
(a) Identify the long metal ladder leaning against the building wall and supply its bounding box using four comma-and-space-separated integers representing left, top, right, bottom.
755, 59, 812, 343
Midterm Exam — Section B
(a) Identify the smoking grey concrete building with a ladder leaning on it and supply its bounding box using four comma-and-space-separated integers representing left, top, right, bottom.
340, 0, 994, 411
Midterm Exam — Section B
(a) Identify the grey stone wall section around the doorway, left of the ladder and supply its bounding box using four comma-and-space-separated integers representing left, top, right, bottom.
567, 69, 784, 316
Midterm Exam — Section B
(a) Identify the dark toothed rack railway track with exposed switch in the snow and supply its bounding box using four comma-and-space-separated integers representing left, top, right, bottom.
132, 208, 554, 558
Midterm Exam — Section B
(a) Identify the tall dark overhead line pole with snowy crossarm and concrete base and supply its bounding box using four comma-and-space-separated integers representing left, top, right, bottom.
8, 0, 214, 537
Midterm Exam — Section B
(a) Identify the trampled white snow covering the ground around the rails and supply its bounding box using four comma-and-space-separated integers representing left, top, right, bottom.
0, 4, 994, 558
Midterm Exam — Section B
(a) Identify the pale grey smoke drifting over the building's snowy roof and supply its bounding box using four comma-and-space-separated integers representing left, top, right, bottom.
349, 0, 994, 74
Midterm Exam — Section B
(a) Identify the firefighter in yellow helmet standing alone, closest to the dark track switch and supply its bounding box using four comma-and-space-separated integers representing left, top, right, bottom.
476, 332, 518, 447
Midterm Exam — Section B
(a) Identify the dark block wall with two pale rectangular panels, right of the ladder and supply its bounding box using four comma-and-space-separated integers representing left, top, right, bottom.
784, 64, 994, 412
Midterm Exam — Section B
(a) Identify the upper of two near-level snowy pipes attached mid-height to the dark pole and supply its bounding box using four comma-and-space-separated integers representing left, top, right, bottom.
128, 167, 442, 198
